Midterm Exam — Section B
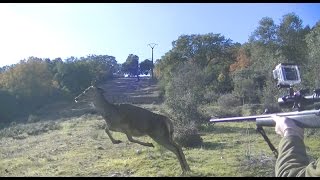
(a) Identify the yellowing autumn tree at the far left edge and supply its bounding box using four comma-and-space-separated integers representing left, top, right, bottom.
0, 57, 58, 118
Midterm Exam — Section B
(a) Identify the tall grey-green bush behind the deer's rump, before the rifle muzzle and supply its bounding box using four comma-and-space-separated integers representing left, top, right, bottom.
165, 63, 206, 124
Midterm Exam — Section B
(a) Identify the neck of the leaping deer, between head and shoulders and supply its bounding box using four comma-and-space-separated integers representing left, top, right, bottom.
93, 93, 119, 119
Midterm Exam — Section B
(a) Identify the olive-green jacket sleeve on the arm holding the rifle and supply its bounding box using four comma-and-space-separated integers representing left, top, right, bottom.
275, 136, 309, 177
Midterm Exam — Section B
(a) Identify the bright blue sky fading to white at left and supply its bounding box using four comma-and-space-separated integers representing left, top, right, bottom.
0, 3, 320, 67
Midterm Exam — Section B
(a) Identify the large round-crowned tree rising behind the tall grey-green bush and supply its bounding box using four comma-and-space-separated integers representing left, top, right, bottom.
155, 33, 236, 96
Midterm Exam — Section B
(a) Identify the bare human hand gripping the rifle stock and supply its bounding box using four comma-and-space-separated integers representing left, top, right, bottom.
272, 115, 304, 139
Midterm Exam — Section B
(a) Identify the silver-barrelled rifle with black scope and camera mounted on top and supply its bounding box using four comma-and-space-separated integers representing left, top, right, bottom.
210, 63, 320, 158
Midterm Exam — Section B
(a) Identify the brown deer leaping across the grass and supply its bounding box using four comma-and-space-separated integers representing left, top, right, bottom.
75, 85, 191, 175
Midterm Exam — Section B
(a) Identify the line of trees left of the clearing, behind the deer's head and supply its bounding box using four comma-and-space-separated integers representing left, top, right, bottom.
0, 55, 118, 122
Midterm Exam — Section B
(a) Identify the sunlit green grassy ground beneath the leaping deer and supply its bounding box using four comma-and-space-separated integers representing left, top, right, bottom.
0, 77, 320, 177
